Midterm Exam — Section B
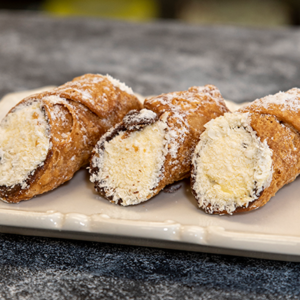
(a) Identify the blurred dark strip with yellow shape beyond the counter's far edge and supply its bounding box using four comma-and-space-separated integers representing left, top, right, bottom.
0, 0, 300, 27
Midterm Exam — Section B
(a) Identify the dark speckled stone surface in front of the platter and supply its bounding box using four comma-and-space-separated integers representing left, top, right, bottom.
0, 235, 300, 300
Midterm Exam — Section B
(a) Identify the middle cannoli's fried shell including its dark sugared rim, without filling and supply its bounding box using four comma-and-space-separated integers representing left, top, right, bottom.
90, 85, 228, 206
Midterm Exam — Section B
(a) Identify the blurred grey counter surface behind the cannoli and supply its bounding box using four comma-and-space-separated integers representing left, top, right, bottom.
0, 13, 300, 102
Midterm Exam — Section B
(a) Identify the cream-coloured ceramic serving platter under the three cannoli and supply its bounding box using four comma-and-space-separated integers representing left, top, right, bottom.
0, 87, 300, 261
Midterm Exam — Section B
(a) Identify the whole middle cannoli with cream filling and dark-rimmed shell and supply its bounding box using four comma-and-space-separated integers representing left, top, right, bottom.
90, 85, 228, 206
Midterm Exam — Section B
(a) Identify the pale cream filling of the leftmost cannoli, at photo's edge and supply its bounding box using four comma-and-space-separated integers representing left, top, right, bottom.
0, 102, 50, 189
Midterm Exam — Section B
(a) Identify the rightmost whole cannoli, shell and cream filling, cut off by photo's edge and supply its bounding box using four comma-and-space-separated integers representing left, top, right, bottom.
191, 88, 300, 214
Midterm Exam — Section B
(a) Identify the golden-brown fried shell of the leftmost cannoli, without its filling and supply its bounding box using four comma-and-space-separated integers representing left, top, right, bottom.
0, 74, 142, 203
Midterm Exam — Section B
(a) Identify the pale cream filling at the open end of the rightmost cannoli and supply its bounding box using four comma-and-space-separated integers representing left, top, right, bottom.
193, 113, 273, 213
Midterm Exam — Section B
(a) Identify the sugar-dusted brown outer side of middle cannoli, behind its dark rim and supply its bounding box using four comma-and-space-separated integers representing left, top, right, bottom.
144, 85, 229, 194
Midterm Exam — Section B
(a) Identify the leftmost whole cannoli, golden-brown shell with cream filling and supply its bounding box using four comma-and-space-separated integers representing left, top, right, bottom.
0, 74, 142, 203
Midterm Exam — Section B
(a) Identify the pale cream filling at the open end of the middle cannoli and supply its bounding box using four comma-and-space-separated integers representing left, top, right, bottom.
99, 121, 167, 206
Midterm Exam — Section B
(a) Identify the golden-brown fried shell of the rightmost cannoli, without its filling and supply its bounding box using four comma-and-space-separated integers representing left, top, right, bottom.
191, 88, 300, 214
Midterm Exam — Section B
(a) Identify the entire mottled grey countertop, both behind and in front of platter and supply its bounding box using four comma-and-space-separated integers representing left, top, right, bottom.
0, 12, 300, 299
